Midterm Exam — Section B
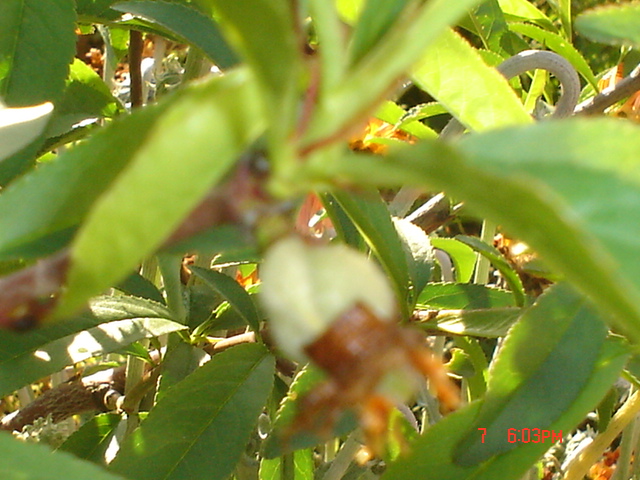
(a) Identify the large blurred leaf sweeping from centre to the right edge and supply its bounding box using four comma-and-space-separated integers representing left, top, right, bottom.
325, 129, 640, 343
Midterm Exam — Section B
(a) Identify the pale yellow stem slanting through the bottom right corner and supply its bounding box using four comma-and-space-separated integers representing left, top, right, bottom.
564, 391, 640, 480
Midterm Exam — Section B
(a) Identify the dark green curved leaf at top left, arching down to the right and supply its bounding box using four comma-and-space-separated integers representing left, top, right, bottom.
112, 0, 238, 69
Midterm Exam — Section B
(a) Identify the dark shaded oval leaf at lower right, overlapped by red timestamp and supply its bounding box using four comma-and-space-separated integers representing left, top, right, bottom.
454, 284, 607, 466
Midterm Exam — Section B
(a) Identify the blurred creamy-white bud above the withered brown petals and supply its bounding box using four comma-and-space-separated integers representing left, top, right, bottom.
260, 237, 396, 361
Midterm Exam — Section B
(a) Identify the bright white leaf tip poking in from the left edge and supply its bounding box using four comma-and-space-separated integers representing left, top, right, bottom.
0, 102, 53, 161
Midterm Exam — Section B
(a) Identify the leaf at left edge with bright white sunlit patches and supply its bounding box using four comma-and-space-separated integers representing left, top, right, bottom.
0, 296, 185, 395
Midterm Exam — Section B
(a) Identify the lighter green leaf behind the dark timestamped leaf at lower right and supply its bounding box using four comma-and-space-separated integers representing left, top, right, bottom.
382, 336, 628, 480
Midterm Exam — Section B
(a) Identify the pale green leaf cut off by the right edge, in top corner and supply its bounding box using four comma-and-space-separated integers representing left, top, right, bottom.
576, 4, 640, 48
